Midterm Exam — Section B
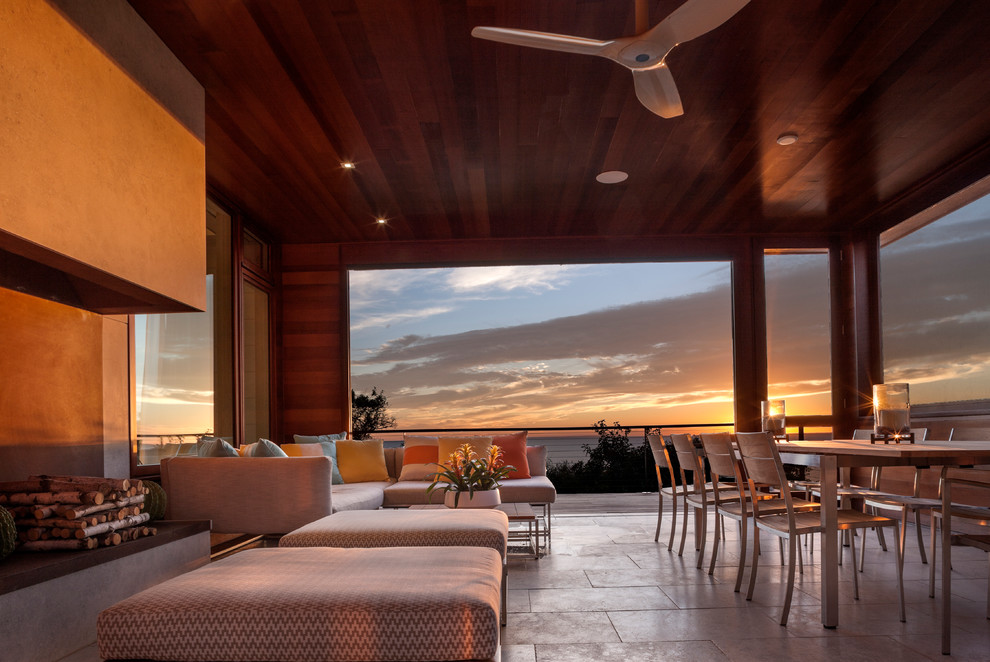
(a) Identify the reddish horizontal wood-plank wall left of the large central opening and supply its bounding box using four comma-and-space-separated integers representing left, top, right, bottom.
278, 244, 350, 441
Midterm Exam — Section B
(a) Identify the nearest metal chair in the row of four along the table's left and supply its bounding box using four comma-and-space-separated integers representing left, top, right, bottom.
736, 432, 905, 625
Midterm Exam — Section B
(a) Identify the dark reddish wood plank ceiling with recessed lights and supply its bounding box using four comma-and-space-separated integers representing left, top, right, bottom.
130, 0, 990, 243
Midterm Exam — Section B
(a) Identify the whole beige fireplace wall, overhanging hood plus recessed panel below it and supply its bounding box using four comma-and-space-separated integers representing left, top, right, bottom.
0, 0, 206, 480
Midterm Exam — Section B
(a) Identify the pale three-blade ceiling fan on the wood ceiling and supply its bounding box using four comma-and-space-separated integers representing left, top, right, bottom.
471, 0, 749, 117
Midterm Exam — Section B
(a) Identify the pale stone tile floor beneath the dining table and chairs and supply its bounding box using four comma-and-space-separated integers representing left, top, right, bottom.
56, 508, 990, 662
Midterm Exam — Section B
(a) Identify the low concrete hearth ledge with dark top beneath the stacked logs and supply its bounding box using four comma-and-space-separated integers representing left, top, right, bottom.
0, 521, 210, 660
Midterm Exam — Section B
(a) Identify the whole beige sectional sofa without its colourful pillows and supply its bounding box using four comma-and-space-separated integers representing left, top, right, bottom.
161, 446, 557, 535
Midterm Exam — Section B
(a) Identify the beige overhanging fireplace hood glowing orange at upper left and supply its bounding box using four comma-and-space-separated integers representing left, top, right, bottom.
0, 0, 206, 312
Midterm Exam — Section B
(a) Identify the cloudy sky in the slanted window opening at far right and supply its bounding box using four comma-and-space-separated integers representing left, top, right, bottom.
880, 196, 990, 404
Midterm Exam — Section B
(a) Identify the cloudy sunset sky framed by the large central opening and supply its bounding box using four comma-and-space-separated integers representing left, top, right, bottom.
349, 262, 733, 429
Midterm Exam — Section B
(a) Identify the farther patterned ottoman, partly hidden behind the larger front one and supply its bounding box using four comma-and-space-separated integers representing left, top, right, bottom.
278, 508, 509, 556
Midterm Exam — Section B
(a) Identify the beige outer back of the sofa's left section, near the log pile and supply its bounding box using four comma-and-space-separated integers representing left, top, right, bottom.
161, 457, 333, 535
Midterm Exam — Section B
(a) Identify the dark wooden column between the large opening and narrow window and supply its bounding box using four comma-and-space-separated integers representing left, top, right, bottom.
732, 240, 767, 432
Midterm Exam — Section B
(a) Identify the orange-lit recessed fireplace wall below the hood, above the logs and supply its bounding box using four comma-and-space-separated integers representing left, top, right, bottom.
0, 289, 130, 480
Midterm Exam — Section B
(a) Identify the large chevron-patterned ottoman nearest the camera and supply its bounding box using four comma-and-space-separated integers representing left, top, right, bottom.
97, 547, 502, 662
